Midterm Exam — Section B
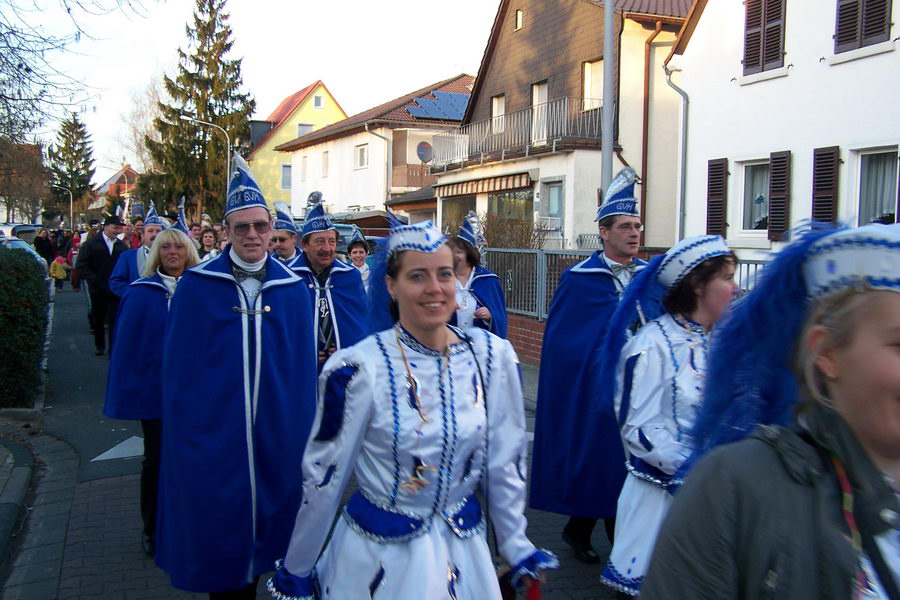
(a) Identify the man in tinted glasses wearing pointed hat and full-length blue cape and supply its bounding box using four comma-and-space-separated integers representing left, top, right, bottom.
156, 154, 316, 598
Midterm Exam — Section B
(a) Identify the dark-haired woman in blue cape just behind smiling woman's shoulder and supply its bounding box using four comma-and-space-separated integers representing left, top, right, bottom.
447, 211, 508, 338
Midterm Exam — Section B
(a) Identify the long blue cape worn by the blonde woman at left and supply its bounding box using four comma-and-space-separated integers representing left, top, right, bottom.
103, 270, 169, 420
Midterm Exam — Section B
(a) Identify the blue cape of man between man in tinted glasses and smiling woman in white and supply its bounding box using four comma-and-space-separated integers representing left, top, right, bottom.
283, 251, 371, 364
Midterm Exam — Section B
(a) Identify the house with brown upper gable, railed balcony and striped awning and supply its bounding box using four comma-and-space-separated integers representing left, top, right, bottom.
432, 0, 690, 248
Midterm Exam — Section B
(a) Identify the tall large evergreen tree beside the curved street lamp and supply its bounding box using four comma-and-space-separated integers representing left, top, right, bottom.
141, 0, 256, 218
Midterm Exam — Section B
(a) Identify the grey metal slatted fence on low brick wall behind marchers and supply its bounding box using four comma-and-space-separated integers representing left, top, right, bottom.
482, 248, 765, 319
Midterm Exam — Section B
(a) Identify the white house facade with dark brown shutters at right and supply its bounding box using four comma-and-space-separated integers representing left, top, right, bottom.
668, 0, 900, 258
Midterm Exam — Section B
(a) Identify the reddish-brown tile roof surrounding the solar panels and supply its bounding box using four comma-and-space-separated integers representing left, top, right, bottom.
275, 73, 475, 152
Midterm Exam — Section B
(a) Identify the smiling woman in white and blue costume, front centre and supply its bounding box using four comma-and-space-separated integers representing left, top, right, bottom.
268, 221, 558, 600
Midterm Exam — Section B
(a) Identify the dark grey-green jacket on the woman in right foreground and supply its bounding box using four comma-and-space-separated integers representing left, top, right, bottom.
641, 405, 900, 600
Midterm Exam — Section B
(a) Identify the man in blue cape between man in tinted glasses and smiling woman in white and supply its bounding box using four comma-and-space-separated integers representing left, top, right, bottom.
287, 192, 371, 369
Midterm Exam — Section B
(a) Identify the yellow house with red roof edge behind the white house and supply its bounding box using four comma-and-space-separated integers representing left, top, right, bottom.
247, 80, 347, 205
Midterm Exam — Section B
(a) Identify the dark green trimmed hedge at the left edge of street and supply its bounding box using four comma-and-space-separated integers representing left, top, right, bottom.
0, 248, 48, 407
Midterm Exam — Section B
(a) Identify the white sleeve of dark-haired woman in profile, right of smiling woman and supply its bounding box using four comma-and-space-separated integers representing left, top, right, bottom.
616, 340, 687, 475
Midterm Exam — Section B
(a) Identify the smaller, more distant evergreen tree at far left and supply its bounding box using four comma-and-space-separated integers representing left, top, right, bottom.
44, 113, 94, 220
